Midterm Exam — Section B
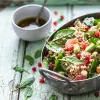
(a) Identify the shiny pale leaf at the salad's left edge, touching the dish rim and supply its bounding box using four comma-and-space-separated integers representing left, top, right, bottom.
46, 41, 64, 53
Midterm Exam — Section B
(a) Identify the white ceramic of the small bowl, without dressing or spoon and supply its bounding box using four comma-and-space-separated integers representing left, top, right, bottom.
12, 4, 52, 41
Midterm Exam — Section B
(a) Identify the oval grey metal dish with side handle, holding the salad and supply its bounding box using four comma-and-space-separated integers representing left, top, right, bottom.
39, 12, 100, 95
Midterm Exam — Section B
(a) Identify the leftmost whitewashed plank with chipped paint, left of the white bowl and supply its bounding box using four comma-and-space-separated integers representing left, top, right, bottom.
0, 8, 22, 100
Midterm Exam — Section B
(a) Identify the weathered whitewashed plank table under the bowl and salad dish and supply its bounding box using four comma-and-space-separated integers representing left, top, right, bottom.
0, 6, 100, 100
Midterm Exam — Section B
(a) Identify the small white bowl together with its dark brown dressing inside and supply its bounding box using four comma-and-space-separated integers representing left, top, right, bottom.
12, 4, 52, 41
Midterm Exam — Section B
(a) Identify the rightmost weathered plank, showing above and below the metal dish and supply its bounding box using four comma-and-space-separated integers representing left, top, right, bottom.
71, 6, 100, 100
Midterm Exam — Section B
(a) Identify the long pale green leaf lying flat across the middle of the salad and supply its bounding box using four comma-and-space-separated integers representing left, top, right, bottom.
60, 56, 83, 64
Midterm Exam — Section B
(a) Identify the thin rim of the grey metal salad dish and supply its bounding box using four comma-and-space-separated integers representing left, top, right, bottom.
42, 12, 100, 83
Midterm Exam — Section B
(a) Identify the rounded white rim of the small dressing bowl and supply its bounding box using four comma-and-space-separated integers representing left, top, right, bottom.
11, 4, 52, 31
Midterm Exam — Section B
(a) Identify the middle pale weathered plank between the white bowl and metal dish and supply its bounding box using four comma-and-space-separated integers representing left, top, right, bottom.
19, 7, 68, 100
